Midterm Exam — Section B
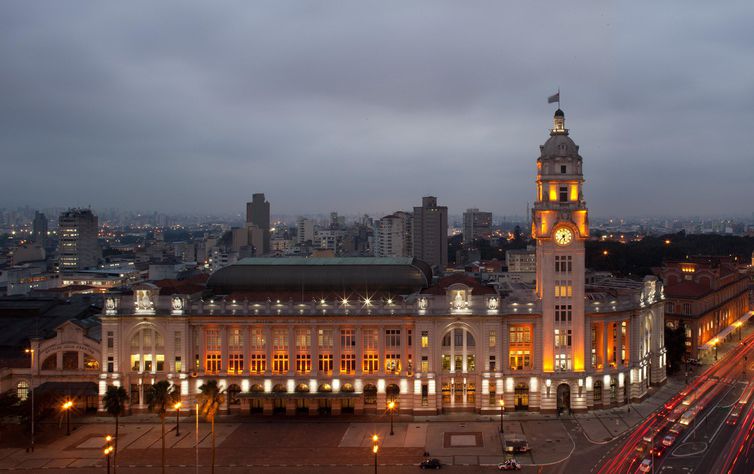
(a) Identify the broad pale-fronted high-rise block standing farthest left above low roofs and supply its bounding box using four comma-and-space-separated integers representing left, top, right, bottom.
58, 209, 102, 271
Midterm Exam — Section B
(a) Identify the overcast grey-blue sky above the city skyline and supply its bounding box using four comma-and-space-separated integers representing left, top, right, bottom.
0, 0, 754, 216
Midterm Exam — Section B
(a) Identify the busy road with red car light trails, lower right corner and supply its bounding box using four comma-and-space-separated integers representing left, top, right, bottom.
594, 335, 754, 474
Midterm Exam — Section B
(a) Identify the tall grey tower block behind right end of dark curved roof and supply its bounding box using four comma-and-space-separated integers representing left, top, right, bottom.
412, 196, 448, 273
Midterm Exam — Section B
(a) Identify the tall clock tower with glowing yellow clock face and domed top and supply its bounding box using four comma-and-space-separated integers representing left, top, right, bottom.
532, 109, 589, 377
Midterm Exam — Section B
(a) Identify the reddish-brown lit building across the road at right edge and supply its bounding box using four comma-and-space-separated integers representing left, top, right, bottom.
657, 257, 751, 358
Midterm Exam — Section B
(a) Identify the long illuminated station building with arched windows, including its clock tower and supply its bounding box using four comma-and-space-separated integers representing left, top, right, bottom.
99, 111, 665, 415
